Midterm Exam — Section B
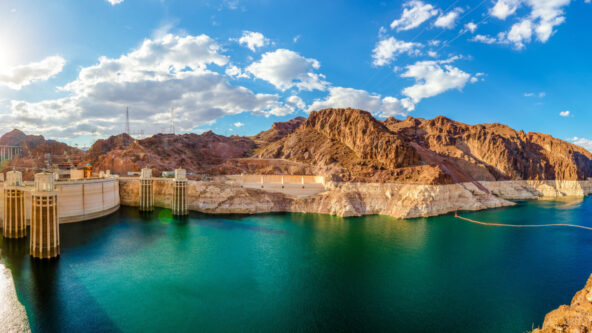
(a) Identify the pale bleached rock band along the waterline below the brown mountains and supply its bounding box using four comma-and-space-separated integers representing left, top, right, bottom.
120, 179, 592, 218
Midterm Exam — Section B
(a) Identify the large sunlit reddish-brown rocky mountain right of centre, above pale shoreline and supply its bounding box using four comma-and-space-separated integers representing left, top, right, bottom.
256, 109, 592, 184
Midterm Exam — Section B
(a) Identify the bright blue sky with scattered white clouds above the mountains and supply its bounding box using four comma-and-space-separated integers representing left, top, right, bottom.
0, 0, 592, 151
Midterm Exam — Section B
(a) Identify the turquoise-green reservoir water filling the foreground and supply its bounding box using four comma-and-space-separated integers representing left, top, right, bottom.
2, 198, 592, 332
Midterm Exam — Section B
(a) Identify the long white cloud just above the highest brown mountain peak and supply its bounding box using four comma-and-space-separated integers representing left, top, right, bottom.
308, 87, 414, 117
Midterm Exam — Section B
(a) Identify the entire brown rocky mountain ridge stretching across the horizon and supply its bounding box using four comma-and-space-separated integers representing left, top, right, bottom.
0, 109, 592, 184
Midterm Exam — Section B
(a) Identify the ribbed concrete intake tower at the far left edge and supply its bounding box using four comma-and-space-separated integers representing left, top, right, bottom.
2, 171, 27, 238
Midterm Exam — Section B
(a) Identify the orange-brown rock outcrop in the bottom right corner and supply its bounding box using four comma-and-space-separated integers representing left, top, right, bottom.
533, 275, 592, 333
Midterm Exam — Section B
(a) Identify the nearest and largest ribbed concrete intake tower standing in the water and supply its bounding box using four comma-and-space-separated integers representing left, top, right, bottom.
30, 173, 60, 259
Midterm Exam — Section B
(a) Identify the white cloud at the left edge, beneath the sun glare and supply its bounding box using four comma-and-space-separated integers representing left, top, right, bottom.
0, 56, 66, 90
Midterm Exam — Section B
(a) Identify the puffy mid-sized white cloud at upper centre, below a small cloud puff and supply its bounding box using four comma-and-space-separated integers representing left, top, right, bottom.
246, 49, 328, 91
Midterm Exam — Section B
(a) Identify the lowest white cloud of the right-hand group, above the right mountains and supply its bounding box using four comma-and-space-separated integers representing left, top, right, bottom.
401, 58, 471, 103
